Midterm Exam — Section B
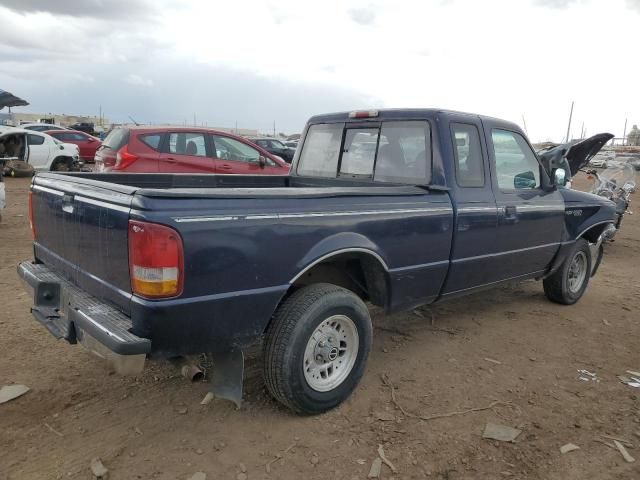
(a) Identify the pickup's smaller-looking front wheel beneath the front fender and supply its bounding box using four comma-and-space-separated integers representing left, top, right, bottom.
542, 238, 592, 305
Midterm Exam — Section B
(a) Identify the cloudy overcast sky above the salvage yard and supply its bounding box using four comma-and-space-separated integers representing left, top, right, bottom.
0, 0, 640, 141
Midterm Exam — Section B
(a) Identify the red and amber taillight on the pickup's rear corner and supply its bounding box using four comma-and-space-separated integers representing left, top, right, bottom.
129, 220, 184, 298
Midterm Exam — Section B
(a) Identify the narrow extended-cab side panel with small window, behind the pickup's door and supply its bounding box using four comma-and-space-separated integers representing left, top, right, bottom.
440, 115, 498, 297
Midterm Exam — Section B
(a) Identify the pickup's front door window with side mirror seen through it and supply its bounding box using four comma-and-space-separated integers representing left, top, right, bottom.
491, 129, 540, 190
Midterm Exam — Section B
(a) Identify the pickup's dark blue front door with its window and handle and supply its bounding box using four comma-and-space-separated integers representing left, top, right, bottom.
483, 120, 564, 280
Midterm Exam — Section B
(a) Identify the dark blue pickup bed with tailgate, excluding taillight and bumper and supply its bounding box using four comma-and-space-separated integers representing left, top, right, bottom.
32, 173, 453, 354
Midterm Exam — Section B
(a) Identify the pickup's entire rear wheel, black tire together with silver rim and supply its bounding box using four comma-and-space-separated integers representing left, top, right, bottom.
264, 283, 372, 415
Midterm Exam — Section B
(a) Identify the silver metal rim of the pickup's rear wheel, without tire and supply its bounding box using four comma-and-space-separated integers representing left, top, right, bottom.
302, 315, 359, 392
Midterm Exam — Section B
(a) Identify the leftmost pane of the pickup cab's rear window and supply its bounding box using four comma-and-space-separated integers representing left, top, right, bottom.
297, 123, 344, 177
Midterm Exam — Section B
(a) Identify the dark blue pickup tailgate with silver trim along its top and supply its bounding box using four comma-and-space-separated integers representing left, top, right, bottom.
32, 173, 136, 313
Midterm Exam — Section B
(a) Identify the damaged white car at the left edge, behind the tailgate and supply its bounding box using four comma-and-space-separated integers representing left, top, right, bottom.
0, 128, 79, 172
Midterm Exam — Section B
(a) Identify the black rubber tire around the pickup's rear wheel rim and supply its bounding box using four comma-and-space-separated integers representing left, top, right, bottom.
263, 283, 373, 415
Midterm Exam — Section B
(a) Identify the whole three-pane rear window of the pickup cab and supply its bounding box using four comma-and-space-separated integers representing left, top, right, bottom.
297, 120, 431, 185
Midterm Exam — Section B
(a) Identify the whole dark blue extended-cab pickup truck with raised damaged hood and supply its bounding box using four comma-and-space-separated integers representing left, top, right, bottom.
18, 109, 615, 414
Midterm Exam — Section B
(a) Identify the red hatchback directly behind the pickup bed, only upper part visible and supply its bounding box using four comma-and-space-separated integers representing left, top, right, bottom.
95, 126, 289, 175
